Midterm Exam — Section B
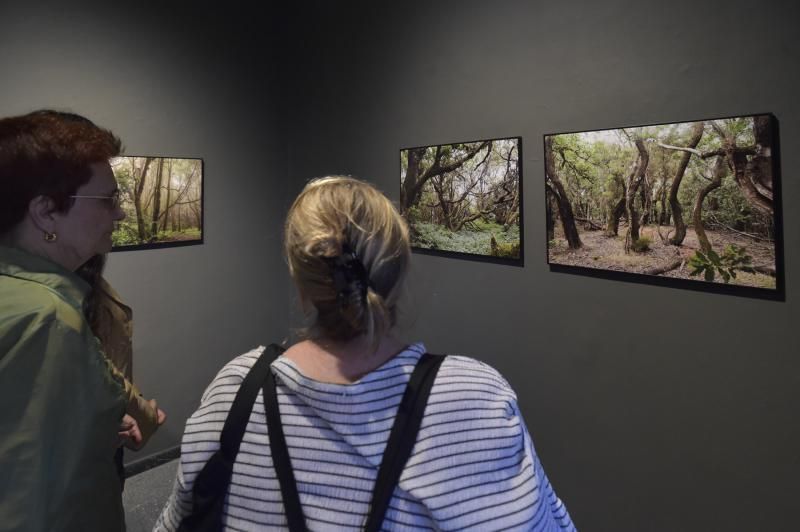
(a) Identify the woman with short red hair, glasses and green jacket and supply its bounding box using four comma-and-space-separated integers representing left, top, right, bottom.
0, 111, 139, 531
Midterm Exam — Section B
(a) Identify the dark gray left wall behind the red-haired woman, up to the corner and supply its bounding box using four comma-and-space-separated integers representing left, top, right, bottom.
0, 2, 288, 461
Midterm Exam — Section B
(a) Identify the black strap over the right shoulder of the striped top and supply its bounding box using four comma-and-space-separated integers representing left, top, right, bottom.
364, 353, 445, 532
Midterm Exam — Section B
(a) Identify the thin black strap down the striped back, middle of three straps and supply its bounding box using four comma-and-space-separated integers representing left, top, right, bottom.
264, 360, 306, 532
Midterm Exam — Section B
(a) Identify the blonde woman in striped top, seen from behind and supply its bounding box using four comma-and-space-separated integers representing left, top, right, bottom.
156, 177, 574, 530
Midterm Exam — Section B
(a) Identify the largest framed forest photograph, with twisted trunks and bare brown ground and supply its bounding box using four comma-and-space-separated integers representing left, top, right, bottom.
544, 114, 784, 299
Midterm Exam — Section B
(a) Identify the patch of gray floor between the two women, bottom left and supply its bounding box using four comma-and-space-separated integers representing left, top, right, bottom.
122, 458, 178, 532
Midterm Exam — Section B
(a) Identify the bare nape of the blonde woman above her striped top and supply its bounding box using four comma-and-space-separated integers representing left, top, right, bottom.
284, 336, 408, 384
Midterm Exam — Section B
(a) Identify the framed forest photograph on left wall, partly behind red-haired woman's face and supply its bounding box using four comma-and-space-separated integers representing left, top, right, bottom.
111, 156, 203, 251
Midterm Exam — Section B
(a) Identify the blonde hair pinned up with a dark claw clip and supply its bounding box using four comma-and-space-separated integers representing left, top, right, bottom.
284, 176, 411, 348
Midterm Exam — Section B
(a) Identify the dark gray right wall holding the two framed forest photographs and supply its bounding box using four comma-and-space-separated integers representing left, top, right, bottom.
289, 1, 800, 531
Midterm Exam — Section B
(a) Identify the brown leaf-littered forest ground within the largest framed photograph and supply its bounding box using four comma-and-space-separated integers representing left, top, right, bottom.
548, 224, 775, 289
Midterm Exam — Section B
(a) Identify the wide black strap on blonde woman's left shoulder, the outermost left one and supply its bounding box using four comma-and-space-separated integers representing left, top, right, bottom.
178, 344, 284, 532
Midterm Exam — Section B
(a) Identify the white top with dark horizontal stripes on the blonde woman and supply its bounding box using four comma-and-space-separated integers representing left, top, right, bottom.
155, 344, 575, 531
